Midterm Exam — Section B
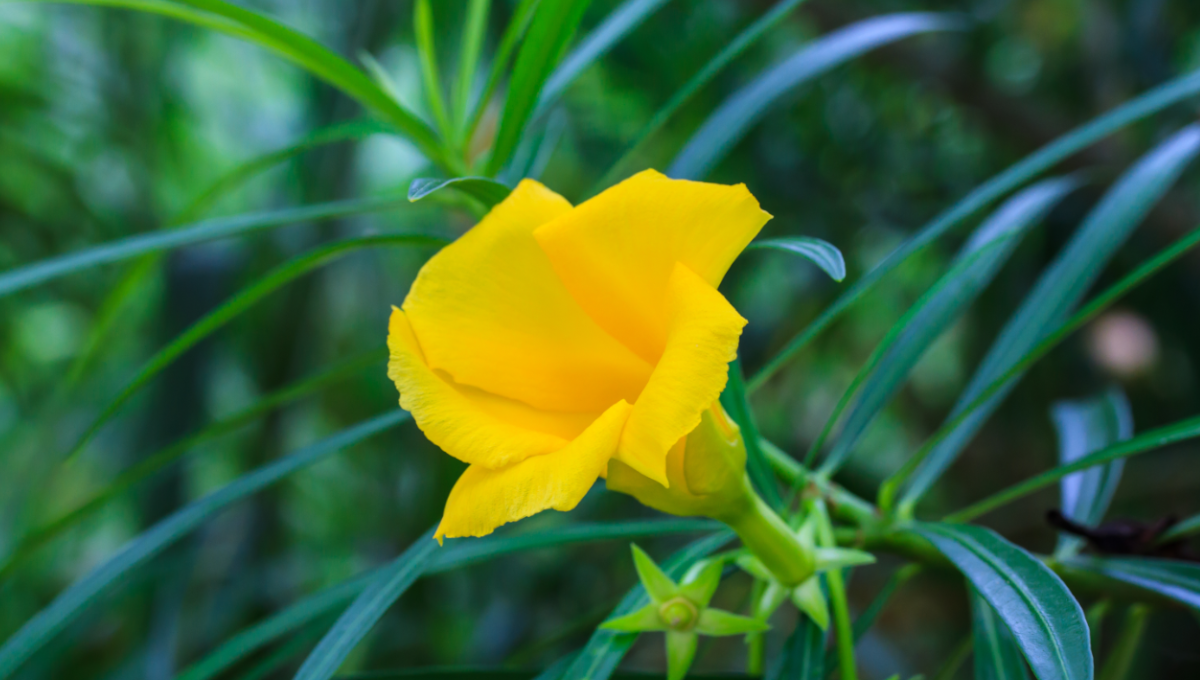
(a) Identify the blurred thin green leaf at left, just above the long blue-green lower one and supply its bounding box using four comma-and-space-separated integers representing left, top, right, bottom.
0, 348, 388, 582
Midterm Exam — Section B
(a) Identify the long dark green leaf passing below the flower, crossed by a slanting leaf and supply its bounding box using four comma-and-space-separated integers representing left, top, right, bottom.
176, 519, 720, 680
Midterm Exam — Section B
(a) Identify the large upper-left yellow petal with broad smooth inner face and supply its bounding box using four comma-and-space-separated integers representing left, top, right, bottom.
403, 180, 650, 414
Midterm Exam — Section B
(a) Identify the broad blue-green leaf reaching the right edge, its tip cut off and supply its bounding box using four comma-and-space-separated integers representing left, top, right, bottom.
902, 125, 1200, 505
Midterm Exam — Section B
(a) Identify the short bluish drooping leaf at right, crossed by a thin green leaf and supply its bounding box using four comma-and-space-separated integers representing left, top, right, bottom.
1050, 387, 1133, 558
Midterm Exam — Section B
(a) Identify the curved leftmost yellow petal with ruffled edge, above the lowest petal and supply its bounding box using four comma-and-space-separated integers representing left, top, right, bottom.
388, 307, 596, 468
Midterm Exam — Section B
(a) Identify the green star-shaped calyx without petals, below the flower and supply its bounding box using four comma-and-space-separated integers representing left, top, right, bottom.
600, 546, 770, 680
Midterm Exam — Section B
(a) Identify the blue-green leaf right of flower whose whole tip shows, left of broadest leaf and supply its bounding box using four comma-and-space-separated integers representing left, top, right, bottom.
805, 179, 1079, 475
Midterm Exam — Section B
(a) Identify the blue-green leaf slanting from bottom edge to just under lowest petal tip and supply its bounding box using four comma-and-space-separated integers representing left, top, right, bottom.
295, 529, 438, 680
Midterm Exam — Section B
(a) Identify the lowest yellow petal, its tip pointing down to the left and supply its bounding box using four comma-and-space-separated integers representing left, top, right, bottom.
434, 402, 631, 541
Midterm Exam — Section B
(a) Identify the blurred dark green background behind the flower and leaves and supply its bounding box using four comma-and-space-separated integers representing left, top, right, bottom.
0, 0, 1200, 679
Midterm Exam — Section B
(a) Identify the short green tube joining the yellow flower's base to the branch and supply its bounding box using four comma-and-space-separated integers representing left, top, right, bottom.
715, 480, 815, 586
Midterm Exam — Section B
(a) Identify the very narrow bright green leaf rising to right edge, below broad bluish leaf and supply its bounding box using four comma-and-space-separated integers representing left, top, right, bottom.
878, 228, 1200, 517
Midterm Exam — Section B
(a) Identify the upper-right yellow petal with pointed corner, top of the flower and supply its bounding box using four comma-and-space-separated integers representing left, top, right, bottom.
534, 170, 770, 363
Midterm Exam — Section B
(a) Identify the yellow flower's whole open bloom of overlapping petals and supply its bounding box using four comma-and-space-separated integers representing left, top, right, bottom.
388, 170, 770, 541
